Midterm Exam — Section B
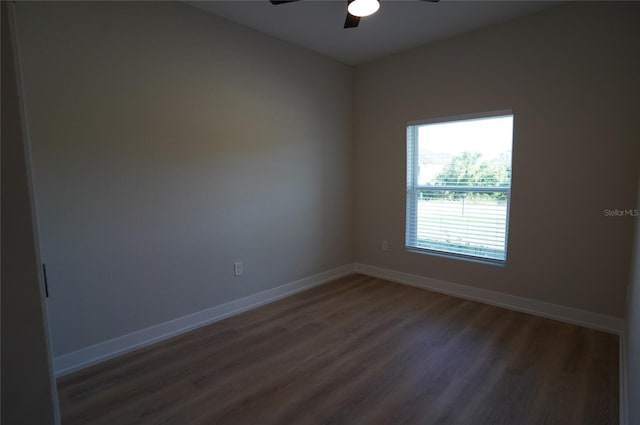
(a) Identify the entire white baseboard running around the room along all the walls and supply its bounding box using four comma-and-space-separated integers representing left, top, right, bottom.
53, 264, 626, 380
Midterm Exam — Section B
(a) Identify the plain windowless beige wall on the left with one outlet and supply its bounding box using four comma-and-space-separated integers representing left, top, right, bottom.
16, 2, 353, 356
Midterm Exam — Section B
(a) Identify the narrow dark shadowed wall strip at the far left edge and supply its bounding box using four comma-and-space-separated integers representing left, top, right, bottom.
0, 2, 59, 425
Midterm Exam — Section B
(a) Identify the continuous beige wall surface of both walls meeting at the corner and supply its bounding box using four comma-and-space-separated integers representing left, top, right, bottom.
11, 2, 640, 368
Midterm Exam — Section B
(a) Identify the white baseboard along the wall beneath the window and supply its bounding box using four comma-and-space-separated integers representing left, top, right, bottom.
355, 264, 624, 335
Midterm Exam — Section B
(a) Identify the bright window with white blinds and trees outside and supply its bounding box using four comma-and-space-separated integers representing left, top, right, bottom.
406, 111, 513, 263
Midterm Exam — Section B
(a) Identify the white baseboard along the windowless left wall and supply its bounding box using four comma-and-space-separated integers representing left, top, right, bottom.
53, 264, 354, 377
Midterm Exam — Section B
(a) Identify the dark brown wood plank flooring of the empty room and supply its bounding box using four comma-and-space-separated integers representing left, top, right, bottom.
58, 275, 618, 425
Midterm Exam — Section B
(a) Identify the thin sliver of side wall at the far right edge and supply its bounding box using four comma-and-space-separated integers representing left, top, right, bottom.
625, 170, 640, 424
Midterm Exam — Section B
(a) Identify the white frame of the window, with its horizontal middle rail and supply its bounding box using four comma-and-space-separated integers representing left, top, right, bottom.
405, 109, 515, 266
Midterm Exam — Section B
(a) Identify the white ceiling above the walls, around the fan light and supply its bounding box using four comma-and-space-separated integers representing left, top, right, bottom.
187, 0, 559, 65
